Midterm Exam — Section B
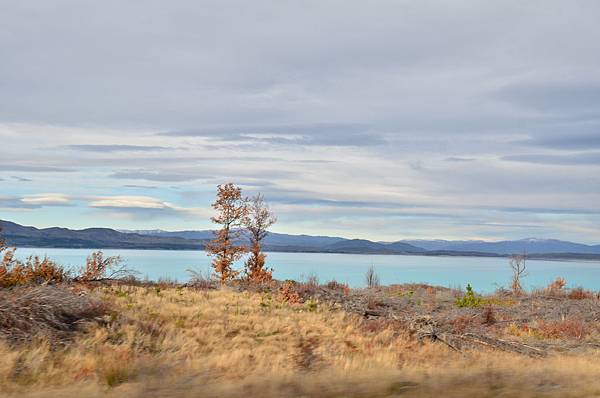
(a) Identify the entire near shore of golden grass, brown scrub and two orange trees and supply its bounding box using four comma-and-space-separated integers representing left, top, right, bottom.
0, 184, 600, 398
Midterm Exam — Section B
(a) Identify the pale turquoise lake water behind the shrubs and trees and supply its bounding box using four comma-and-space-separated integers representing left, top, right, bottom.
11, 248, 600, 292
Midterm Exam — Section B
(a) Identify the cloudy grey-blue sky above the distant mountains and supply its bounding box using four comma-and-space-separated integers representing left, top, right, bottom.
0, 0, 600, 244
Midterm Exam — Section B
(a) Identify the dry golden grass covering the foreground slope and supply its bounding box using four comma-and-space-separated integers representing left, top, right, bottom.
0, 286, 600, 398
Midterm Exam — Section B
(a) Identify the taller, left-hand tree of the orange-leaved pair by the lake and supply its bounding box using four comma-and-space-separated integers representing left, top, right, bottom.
205, 183, 248, 282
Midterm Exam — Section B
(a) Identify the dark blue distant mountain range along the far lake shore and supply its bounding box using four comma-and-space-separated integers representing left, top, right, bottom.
0, 221, 600, 259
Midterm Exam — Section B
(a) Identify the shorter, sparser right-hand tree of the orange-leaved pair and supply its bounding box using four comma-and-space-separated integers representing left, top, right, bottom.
244, 193, 277, 283
